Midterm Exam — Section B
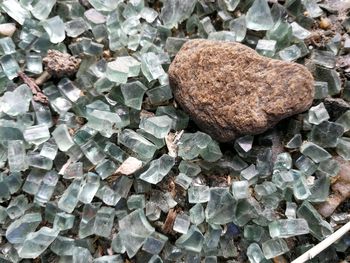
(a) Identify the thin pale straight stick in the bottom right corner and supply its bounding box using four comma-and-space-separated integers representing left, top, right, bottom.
292, 222, 350, 263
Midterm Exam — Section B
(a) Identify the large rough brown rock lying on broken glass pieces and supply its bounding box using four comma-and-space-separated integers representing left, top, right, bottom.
169, 40, 314, 142
